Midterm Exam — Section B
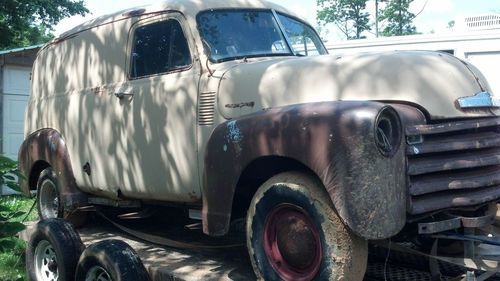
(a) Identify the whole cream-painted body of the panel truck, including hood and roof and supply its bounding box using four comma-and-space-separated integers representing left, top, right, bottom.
25, 0, 496, 202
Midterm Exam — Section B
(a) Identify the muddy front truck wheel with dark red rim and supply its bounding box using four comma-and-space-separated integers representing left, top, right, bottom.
247, 172, 368, 281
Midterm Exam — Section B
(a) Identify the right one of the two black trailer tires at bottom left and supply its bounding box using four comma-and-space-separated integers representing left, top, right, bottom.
75, 239, 150, 281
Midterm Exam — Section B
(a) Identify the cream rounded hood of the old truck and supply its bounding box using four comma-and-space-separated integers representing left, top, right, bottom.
216, 51, 500, 119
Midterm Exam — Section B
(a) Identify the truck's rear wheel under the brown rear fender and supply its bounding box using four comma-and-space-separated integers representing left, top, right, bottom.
36, 167, 87, 227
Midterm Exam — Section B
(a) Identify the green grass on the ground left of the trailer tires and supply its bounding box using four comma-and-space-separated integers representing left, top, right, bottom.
0, 195, 38, 281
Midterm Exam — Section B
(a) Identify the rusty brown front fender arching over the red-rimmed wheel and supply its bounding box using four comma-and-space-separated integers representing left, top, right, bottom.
203, 101, 406, 239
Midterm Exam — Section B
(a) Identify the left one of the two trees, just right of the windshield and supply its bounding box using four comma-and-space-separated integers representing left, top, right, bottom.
317, 0, 370, 39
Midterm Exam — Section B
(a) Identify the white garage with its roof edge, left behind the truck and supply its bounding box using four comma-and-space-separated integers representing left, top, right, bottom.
0, 46, 40, 160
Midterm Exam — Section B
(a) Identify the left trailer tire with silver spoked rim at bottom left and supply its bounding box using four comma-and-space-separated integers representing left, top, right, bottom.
26, 219, 85, 281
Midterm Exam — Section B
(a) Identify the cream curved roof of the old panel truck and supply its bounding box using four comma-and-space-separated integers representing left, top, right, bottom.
54, 0, 302, 44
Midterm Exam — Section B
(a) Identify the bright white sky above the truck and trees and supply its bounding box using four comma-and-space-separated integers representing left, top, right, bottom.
55, 0, 500, 41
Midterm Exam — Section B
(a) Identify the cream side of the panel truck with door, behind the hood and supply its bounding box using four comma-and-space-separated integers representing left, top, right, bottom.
25, 6, 201, 202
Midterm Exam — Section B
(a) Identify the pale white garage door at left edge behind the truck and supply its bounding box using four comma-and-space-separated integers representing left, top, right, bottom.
2, 66, 31, 160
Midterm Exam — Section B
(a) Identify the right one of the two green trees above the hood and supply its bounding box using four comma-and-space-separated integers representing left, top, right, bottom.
380, 0, 417, 36
